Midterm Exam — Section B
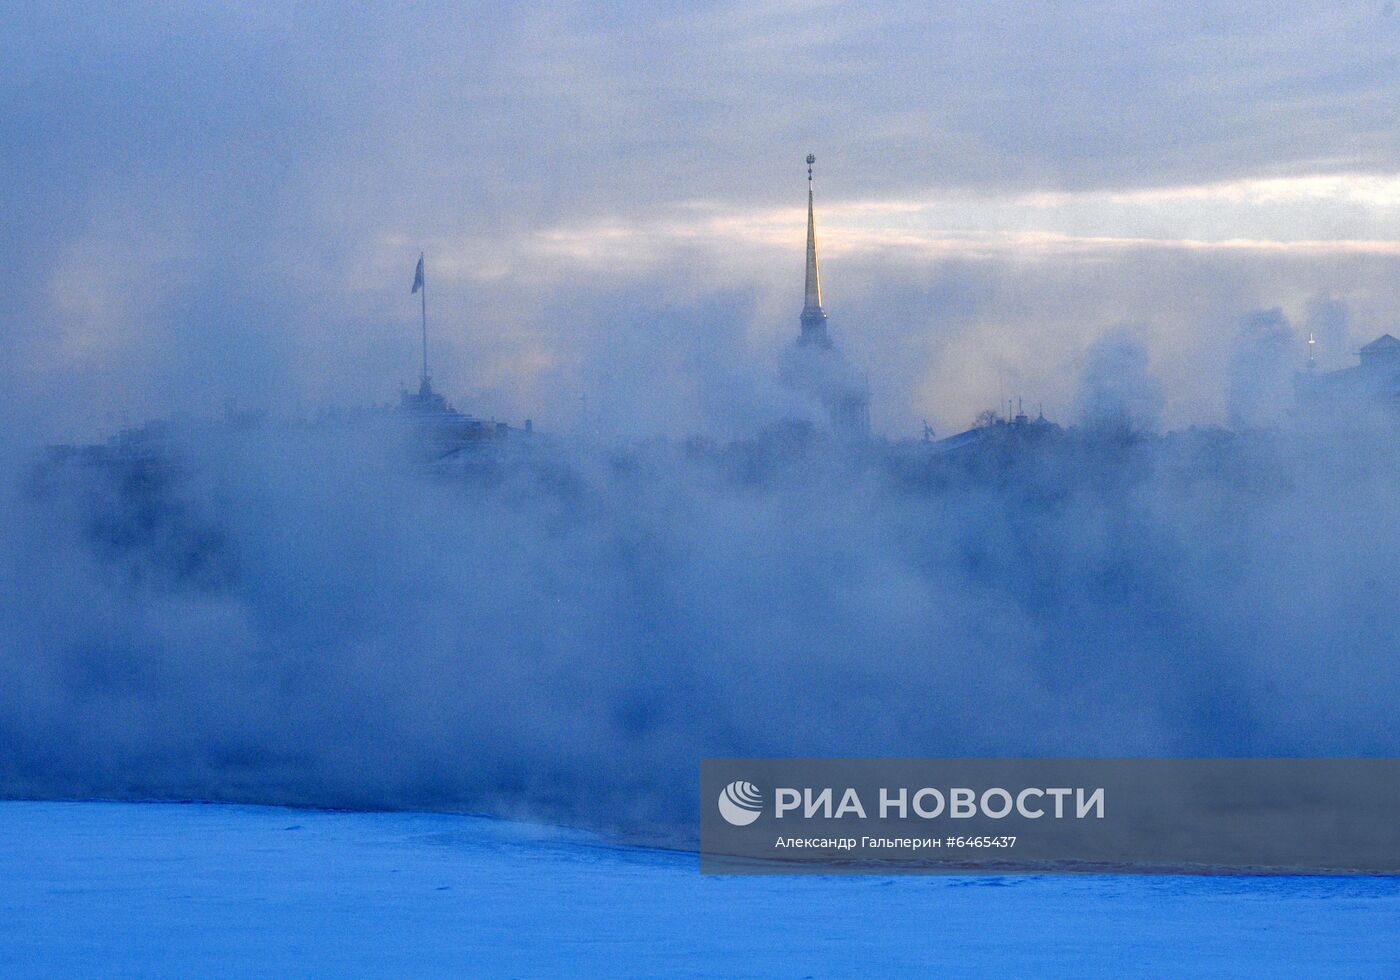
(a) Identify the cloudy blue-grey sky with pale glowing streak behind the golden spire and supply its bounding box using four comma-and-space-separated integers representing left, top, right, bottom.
0, 0, 1400, 440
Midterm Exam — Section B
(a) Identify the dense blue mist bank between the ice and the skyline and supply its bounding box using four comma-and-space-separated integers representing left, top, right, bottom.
0, 421, 1400, 832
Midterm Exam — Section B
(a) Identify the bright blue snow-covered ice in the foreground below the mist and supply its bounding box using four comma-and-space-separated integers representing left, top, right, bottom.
0, 802, 1400, 977
